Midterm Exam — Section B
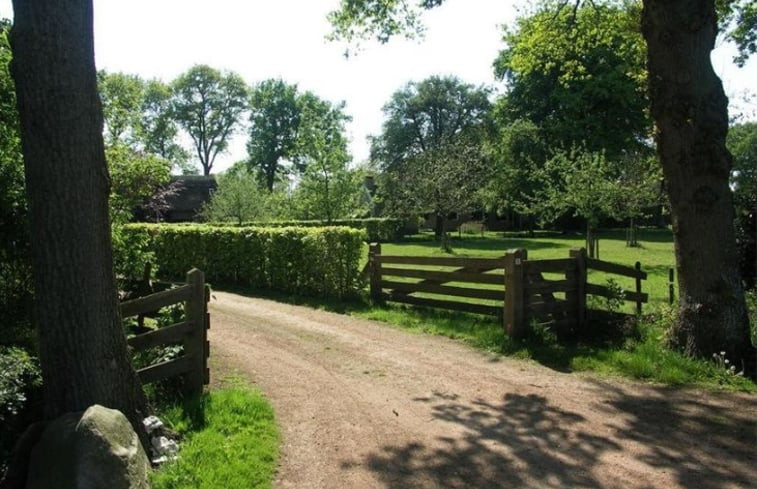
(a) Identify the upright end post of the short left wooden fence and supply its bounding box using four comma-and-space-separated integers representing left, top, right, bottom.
184, 268, 207, 396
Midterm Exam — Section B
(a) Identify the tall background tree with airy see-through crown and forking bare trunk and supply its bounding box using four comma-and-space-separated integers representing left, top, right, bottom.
173, 65, 247, 175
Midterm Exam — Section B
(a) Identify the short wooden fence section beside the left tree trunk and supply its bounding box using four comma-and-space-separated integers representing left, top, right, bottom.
121, 268, 210, 396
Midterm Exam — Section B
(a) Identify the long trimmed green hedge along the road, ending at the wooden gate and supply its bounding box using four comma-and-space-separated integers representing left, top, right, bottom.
124, 224, 365, 298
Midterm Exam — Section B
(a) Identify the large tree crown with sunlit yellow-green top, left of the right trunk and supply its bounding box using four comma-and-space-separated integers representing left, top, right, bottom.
494, 2, 651, 158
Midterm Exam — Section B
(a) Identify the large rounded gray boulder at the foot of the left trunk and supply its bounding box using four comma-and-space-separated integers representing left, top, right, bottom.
26, 405, 150, 489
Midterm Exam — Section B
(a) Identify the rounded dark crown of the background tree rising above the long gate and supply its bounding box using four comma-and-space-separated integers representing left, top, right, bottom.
371, 76, 490, 169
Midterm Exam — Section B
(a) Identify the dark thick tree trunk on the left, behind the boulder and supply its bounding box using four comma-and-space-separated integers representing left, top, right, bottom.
12, 0, 146, 431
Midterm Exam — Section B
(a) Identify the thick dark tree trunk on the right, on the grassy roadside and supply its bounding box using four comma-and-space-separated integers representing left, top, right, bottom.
642, 0, 754, 362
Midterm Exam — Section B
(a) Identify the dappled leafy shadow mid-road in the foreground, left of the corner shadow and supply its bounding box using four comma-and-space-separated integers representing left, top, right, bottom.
354, 393, 619, 488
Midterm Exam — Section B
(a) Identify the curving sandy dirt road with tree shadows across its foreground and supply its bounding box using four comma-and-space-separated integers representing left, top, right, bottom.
210, 292, 757, 489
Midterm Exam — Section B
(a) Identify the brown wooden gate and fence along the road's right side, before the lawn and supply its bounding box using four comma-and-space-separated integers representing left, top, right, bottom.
368, 243, 648, 337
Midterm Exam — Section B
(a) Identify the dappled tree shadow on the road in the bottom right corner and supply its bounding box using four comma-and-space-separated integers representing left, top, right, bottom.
595, 381, 757, 489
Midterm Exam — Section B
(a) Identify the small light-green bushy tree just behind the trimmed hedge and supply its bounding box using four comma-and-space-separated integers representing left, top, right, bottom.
202, 171, 267, 225
